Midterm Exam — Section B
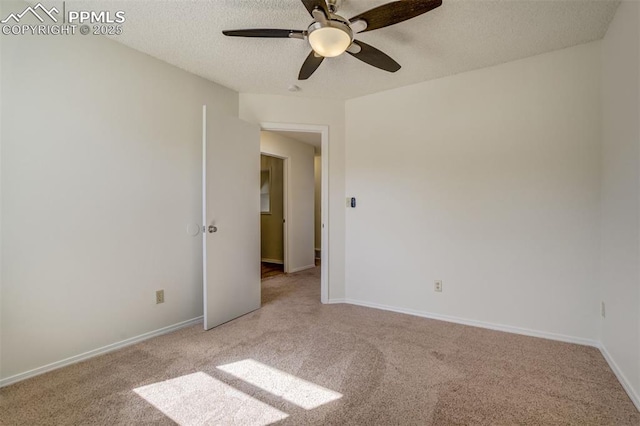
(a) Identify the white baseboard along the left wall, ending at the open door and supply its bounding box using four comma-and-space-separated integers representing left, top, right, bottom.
0, 316, 203, 388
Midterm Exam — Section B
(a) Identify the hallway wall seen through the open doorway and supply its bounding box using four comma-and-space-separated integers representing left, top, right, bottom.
260, 132, 315, 272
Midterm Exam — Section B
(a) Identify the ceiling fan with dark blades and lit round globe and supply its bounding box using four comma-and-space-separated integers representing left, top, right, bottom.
222, 0, 442, 80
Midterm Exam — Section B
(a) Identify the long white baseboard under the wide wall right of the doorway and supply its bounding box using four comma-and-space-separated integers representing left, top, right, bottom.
344, 299, 600, 348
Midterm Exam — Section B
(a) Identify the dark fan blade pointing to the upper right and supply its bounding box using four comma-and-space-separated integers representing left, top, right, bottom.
349, 0, 442, 32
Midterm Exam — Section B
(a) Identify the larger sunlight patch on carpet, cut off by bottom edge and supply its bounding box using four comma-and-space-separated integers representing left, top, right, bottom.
133, 372, 288, 426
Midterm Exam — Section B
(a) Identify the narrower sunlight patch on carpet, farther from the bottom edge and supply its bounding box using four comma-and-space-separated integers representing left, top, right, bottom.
216, 359, 342, 410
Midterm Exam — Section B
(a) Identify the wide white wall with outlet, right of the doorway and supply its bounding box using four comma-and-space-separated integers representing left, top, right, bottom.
346, 42, 601, 342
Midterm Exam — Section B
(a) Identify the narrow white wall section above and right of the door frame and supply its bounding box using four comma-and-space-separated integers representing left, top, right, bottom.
240, 93, 345, 301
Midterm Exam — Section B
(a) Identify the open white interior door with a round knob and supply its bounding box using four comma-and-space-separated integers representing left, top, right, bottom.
202, 106, 260, 330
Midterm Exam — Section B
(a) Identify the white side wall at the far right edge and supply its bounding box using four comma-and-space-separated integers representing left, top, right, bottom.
601, 2, 640, 409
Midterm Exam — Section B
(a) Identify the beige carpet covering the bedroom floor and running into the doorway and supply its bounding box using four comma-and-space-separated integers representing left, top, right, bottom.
0, 268, 640, 425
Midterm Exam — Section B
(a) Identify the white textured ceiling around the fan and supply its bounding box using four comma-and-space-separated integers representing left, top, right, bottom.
48, 0, 619, 99
